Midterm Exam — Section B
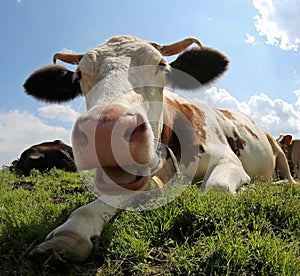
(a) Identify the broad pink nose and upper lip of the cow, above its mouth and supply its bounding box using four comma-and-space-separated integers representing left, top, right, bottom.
72, 109, 154, 169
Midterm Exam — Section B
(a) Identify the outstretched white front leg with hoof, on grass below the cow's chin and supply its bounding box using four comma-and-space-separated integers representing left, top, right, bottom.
31, 197, 123, 262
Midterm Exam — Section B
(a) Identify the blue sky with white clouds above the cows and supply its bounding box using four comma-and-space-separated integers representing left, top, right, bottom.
0, 0, 300, 167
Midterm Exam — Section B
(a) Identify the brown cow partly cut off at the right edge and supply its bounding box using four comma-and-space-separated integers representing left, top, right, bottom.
276, 135, 300, 179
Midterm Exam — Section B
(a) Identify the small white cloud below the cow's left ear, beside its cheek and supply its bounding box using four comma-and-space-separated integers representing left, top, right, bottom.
38, 104, 80, 122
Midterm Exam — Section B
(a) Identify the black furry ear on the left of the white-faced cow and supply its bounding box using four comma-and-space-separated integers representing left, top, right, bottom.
24, 65, 81, 103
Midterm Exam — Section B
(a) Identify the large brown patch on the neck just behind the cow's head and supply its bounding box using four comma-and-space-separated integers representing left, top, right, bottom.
161, 98, 206, 166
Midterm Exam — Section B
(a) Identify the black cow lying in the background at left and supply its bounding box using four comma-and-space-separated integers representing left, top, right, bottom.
11, 140, 77, 176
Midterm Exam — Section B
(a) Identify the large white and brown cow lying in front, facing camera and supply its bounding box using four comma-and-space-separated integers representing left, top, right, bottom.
24, 35, 294, 262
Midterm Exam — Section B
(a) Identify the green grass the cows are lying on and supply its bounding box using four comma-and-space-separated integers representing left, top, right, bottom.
0, 170, 300, 275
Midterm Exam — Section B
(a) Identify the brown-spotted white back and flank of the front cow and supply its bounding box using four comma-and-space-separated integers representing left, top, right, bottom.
166, 93, 281, 183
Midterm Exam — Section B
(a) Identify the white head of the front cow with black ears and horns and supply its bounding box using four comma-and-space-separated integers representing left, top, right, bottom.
24, 36, 228, 194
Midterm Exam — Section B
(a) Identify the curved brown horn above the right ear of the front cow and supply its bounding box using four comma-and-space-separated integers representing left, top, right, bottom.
151, 37, 203, 56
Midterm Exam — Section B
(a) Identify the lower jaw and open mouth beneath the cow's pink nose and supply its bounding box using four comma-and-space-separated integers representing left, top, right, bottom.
94, 167, 149, 195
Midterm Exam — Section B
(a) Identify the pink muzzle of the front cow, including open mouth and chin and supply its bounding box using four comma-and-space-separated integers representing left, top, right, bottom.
72, 108, 159, 193
